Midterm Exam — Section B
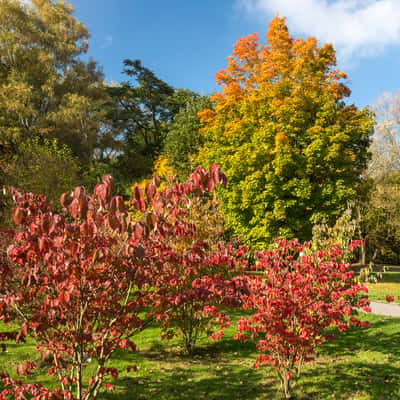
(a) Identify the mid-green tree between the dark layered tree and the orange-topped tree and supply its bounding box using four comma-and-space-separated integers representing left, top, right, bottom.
164, 95, 213, 177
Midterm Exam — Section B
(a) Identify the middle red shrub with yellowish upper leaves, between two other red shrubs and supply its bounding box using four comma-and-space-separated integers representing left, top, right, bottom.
134, 165, 247, 355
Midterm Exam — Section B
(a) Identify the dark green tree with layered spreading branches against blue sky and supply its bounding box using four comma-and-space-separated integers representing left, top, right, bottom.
107, 59, 194, 178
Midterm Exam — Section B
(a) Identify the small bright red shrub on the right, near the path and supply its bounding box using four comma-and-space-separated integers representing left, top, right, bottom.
236, 240, 368, 398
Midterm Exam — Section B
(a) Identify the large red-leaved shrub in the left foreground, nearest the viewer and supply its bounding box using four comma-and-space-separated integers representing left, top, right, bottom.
0, 180, 148, 399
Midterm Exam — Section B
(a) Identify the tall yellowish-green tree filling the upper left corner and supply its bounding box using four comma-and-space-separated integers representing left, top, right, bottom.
0, 0, 105, 161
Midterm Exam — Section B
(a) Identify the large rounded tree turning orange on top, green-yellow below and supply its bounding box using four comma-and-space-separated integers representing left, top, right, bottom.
198, 17, 373, 246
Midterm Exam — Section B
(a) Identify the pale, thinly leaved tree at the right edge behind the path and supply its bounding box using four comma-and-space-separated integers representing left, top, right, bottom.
358, 90, 400, 263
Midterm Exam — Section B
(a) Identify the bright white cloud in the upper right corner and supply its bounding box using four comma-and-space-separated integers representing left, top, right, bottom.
239, 0, 400, 62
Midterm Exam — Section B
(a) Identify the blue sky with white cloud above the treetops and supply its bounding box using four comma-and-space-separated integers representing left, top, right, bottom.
71, 0, 400, 107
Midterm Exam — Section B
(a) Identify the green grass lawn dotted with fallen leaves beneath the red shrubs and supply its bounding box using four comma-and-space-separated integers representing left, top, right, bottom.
0, 315, 400, 400
